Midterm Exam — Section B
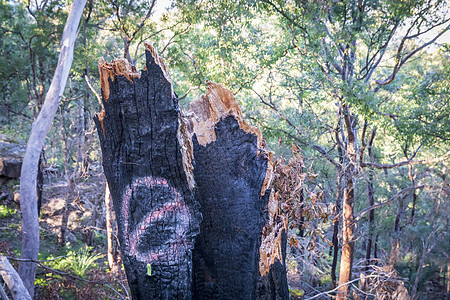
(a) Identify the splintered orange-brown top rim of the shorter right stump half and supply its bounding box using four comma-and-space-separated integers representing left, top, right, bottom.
184, 81, 273, 196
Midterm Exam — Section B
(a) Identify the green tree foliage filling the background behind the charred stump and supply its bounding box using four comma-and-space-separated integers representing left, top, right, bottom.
0, 0, 450, 297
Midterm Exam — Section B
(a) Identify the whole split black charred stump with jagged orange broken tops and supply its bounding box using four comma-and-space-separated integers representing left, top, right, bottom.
95, 45, 289, 299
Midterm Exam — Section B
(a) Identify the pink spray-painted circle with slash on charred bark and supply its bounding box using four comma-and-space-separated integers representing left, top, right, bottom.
122, 176, 190, 263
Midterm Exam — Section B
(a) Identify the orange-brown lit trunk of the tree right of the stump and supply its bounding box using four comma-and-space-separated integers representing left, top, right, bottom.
337, 106, 356, 299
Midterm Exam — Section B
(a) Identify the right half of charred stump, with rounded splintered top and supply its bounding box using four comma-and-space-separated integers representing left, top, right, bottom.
187, 83, 288, 299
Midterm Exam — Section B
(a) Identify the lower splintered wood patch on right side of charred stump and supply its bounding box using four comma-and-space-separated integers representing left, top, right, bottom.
259, 190, 287, 276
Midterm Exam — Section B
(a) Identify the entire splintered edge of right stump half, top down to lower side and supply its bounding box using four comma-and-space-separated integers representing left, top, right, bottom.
182, 81, 287, 276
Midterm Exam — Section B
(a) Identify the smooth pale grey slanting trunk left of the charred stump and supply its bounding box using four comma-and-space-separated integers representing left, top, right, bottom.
19, 0, 86, 296
